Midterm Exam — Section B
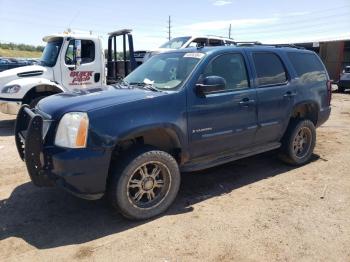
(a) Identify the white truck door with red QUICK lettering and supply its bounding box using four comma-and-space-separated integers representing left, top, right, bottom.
61, 39, 103, 90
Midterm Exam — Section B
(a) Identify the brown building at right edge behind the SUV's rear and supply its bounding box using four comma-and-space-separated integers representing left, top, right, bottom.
296, 40, 350, 82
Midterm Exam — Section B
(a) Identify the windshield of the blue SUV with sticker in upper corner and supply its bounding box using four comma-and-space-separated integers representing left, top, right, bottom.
124, 52, 205, 91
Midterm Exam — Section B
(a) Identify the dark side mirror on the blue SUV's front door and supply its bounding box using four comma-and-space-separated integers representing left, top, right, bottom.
196, 76, 226, 96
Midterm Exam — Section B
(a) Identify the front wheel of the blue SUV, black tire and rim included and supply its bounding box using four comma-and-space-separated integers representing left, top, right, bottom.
107, 146, 181, 220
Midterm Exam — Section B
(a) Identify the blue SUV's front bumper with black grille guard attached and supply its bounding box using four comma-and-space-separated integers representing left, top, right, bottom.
15, 106, 111, 200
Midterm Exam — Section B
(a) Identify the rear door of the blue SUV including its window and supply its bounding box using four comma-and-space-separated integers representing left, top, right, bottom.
250, 51, 296, 145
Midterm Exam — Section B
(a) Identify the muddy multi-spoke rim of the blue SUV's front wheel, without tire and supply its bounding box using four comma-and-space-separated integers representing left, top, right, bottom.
127, 161, 171, 209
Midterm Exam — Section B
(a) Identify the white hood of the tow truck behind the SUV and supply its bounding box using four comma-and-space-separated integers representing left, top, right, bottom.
0, 65, 53, 87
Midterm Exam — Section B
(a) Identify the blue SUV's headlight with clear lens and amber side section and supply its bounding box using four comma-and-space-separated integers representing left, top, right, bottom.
55, 112, 89, 148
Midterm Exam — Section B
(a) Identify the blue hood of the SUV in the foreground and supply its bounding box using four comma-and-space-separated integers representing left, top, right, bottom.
37, 86, 166, 119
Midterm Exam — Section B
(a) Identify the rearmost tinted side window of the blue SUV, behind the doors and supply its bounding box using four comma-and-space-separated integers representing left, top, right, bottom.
288, 52, 327, 83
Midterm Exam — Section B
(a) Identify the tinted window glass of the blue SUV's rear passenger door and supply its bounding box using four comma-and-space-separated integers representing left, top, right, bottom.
253, 52, 287, 86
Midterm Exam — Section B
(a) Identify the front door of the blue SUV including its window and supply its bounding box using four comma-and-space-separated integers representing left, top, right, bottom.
188, 53, 257, 158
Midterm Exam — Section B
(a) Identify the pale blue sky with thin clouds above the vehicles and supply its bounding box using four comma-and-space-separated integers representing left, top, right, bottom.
0, 0, 350, 49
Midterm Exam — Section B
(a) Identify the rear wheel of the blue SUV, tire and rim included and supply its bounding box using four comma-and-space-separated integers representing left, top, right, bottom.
279, 119, 316, 166
